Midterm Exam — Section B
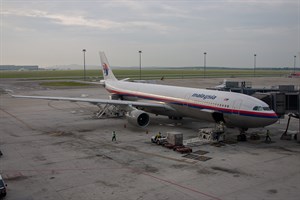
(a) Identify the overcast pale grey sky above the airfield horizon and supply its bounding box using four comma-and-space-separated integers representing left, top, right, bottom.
0, 0, 300, 67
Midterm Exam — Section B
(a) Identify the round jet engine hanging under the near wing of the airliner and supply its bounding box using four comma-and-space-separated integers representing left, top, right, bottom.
125, 109, 150, 127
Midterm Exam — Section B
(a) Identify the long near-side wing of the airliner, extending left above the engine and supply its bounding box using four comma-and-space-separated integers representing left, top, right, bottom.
11, 95, 174, 111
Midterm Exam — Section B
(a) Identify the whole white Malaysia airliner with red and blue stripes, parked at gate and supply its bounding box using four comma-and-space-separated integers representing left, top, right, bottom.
13, 52, 278, 130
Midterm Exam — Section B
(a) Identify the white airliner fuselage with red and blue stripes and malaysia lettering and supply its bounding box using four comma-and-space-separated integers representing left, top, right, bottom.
105, 80, 278, 129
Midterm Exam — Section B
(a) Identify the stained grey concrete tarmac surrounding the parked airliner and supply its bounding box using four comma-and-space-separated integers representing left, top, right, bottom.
0, 77, 300, 200
